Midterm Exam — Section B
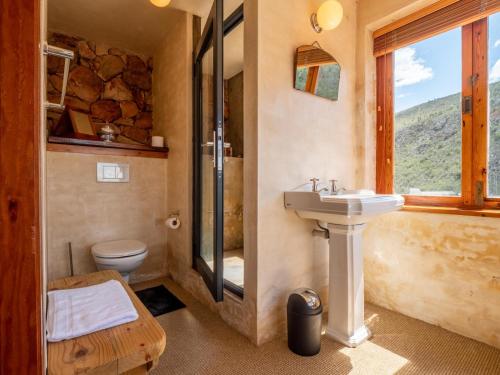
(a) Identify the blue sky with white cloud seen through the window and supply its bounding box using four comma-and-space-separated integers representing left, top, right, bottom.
394, 13, 500, 113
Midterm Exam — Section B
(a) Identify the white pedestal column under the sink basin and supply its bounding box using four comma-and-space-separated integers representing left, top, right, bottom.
326, 224, 371, 348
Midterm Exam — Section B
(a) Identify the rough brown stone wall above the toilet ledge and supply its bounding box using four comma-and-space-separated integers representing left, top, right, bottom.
47, 33, 153, 143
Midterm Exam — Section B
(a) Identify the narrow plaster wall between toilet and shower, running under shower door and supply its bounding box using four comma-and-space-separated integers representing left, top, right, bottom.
153, 12, 255, 340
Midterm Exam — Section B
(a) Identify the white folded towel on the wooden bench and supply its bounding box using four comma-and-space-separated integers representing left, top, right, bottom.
47, 280, 139, 342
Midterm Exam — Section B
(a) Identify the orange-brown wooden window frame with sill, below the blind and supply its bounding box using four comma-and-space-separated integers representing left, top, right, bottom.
376, 17, 500, 217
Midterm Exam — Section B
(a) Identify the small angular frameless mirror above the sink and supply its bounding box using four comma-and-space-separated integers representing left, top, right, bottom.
293, 45, 340, 100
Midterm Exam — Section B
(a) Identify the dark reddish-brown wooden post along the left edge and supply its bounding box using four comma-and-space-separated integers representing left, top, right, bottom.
0, 0, 44, 374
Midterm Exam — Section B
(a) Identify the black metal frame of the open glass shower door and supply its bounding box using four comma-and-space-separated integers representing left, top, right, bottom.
193, 0, 243, 302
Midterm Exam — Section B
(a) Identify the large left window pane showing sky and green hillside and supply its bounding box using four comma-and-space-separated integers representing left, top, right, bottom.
394, 28, 462, 196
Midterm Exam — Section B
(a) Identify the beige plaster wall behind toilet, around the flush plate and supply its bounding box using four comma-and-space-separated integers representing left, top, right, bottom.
47, 152, 167, 282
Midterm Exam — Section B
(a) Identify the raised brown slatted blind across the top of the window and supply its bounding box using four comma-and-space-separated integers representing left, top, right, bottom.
373, 0, 500, 56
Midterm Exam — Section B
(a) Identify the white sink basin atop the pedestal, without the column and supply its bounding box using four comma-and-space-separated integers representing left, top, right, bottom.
285, 190, 404, 225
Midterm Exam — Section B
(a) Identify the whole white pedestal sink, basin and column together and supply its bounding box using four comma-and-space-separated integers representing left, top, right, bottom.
285, 190, 404, 347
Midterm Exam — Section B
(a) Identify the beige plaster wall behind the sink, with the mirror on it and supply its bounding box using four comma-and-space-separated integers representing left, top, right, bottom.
254, 0, 360, 344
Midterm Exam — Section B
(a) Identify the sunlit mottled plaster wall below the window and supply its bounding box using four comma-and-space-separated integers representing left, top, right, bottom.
364, 212, 500, 347
